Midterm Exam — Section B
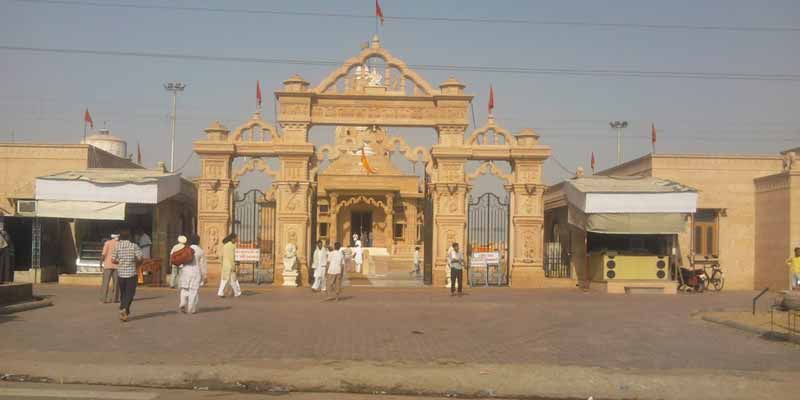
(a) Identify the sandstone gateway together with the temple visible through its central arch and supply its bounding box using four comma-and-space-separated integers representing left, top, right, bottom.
194, 36, 550, 287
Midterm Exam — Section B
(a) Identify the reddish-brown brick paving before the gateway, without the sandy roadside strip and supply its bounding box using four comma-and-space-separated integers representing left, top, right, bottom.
0, 285, 800, 371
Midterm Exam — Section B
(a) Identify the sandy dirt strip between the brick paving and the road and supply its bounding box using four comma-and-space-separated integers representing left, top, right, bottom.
0, 354, 800, 400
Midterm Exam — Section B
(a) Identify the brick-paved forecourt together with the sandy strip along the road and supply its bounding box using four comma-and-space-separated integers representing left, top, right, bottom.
0, 284, 800, 399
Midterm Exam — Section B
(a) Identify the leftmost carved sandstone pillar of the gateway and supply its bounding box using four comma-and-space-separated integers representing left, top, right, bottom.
194, 122, 234, 284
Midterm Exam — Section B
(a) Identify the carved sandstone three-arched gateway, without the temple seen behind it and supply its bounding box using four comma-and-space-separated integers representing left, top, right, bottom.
194, 37, 550, 286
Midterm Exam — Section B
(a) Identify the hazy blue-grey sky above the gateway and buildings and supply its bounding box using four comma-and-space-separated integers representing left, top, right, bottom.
0, 0, 800, 183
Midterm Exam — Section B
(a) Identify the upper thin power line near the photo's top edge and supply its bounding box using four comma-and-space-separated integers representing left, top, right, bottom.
11, 0, 800, 33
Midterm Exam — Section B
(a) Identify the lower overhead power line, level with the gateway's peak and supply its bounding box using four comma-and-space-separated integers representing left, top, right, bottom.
0, 45, 800, 82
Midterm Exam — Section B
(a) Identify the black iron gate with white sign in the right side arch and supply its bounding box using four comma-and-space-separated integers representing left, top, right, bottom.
466, 192, 511, 286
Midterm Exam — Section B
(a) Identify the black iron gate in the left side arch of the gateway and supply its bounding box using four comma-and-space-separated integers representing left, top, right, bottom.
233, 189, 276, 283
